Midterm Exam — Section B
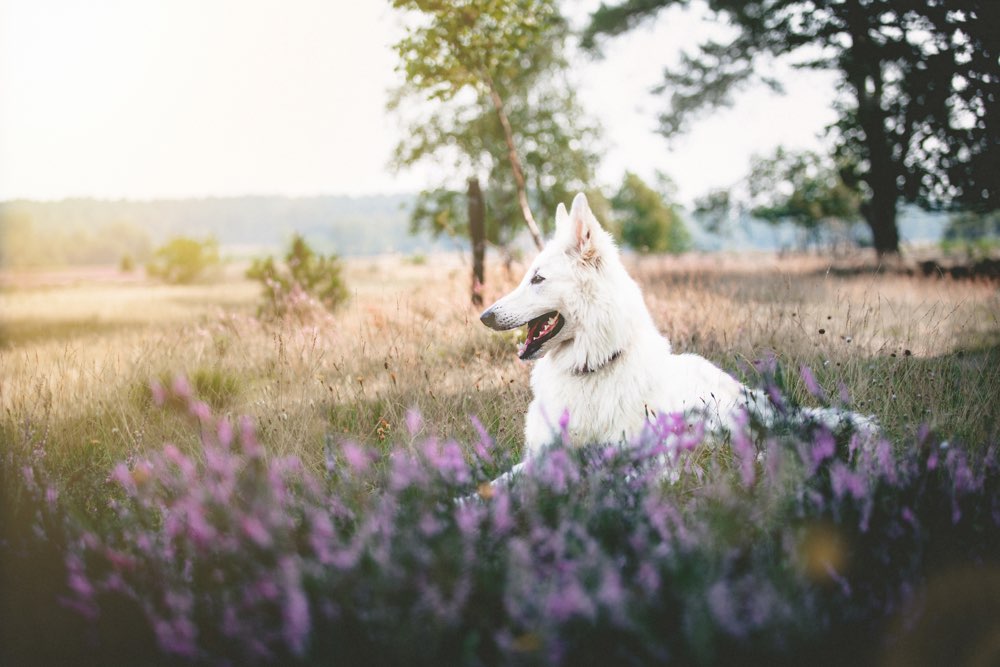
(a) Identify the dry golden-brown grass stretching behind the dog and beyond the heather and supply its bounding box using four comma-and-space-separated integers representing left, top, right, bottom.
0, 255, 1000, 516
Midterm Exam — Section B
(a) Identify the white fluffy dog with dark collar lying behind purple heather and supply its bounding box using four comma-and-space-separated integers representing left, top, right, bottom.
481, 193, 864, 458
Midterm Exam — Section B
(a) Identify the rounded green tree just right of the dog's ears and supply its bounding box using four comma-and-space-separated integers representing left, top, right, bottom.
611, 172, 691, 253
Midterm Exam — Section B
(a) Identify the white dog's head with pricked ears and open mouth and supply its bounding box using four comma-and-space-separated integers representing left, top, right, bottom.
480, 192, 617, 360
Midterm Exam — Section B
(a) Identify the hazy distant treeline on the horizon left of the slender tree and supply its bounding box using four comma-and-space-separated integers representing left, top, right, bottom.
0, 195, 454, 267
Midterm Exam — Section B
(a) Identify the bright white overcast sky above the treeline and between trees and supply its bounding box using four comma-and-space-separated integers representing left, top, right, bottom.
0, 0, 834, 203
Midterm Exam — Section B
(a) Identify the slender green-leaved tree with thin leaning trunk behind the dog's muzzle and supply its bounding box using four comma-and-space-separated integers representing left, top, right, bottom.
390, 0, 596, 300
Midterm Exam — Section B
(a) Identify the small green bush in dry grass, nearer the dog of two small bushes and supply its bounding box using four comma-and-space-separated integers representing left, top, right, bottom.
247, 234, 348, 317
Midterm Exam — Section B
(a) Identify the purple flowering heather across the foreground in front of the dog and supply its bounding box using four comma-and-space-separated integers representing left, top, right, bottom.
48, 374, 1000, 664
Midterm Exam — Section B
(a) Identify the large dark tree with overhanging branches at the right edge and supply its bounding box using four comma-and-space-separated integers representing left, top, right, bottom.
583, 0, 1000, 255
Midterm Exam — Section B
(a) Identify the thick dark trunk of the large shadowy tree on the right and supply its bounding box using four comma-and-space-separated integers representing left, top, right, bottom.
844, 2, 899, 257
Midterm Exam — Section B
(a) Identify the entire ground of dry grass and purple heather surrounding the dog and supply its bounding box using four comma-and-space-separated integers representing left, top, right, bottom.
0, 255, 1000, 665
